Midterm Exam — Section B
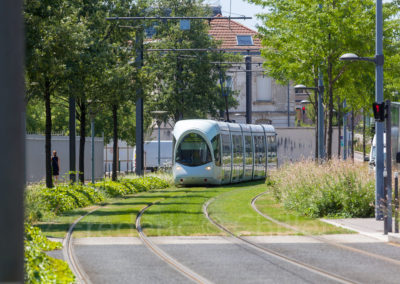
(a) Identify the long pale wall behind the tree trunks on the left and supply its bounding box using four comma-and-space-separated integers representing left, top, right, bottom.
26, 134, 104, 182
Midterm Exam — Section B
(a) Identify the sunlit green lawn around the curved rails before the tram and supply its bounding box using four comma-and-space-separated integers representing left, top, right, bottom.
40, 182, 347, 238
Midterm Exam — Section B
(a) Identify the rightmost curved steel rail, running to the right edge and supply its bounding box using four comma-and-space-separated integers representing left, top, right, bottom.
251, 192, 400, 265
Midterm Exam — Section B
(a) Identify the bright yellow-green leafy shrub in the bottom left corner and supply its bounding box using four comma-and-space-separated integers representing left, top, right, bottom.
24, 224, 75, 284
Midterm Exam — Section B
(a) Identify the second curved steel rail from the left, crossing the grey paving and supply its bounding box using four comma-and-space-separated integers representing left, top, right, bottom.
136, 202, 212, 284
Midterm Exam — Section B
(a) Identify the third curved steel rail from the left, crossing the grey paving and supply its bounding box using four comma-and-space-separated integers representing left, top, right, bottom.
203, 198, 357, 284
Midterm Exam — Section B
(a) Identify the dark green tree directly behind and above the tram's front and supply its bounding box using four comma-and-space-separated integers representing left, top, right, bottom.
145, 0, 237, 122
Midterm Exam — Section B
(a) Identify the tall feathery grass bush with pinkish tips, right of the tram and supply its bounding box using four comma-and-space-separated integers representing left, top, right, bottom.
272, 160, 374, 217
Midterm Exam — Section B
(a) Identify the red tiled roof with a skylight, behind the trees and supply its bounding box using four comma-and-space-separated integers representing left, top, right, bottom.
208, 15, 261, 50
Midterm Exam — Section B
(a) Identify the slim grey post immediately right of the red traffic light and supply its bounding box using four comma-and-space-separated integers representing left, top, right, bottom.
384, 100, 393, 232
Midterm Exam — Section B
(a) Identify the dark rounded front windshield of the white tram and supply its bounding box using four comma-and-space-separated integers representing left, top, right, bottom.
175, 133, 212, 167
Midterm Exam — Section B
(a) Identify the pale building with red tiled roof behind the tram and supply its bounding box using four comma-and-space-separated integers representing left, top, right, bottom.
209, 14, 295, 127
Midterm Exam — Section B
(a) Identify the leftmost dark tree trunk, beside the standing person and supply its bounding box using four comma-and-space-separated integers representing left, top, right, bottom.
44, 78, 53, 188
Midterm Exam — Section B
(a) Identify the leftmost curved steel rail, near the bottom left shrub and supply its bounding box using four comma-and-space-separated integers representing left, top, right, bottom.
63, 206, 101, 284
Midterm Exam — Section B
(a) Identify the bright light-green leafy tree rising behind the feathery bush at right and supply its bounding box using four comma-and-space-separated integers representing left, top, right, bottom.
249, 0, 375, 159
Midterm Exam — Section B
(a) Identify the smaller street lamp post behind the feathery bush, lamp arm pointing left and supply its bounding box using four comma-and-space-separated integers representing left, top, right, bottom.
294, 83, 325, 161
